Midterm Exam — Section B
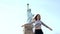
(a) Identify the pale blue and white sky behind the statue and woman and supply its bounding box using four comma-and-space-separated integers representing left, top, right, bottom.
0, 0, 60, 34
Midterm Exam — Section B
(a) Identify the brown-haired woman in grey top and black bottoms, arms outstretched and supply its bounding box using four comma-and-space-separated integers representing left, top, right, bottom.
32, 14, 52, 34
